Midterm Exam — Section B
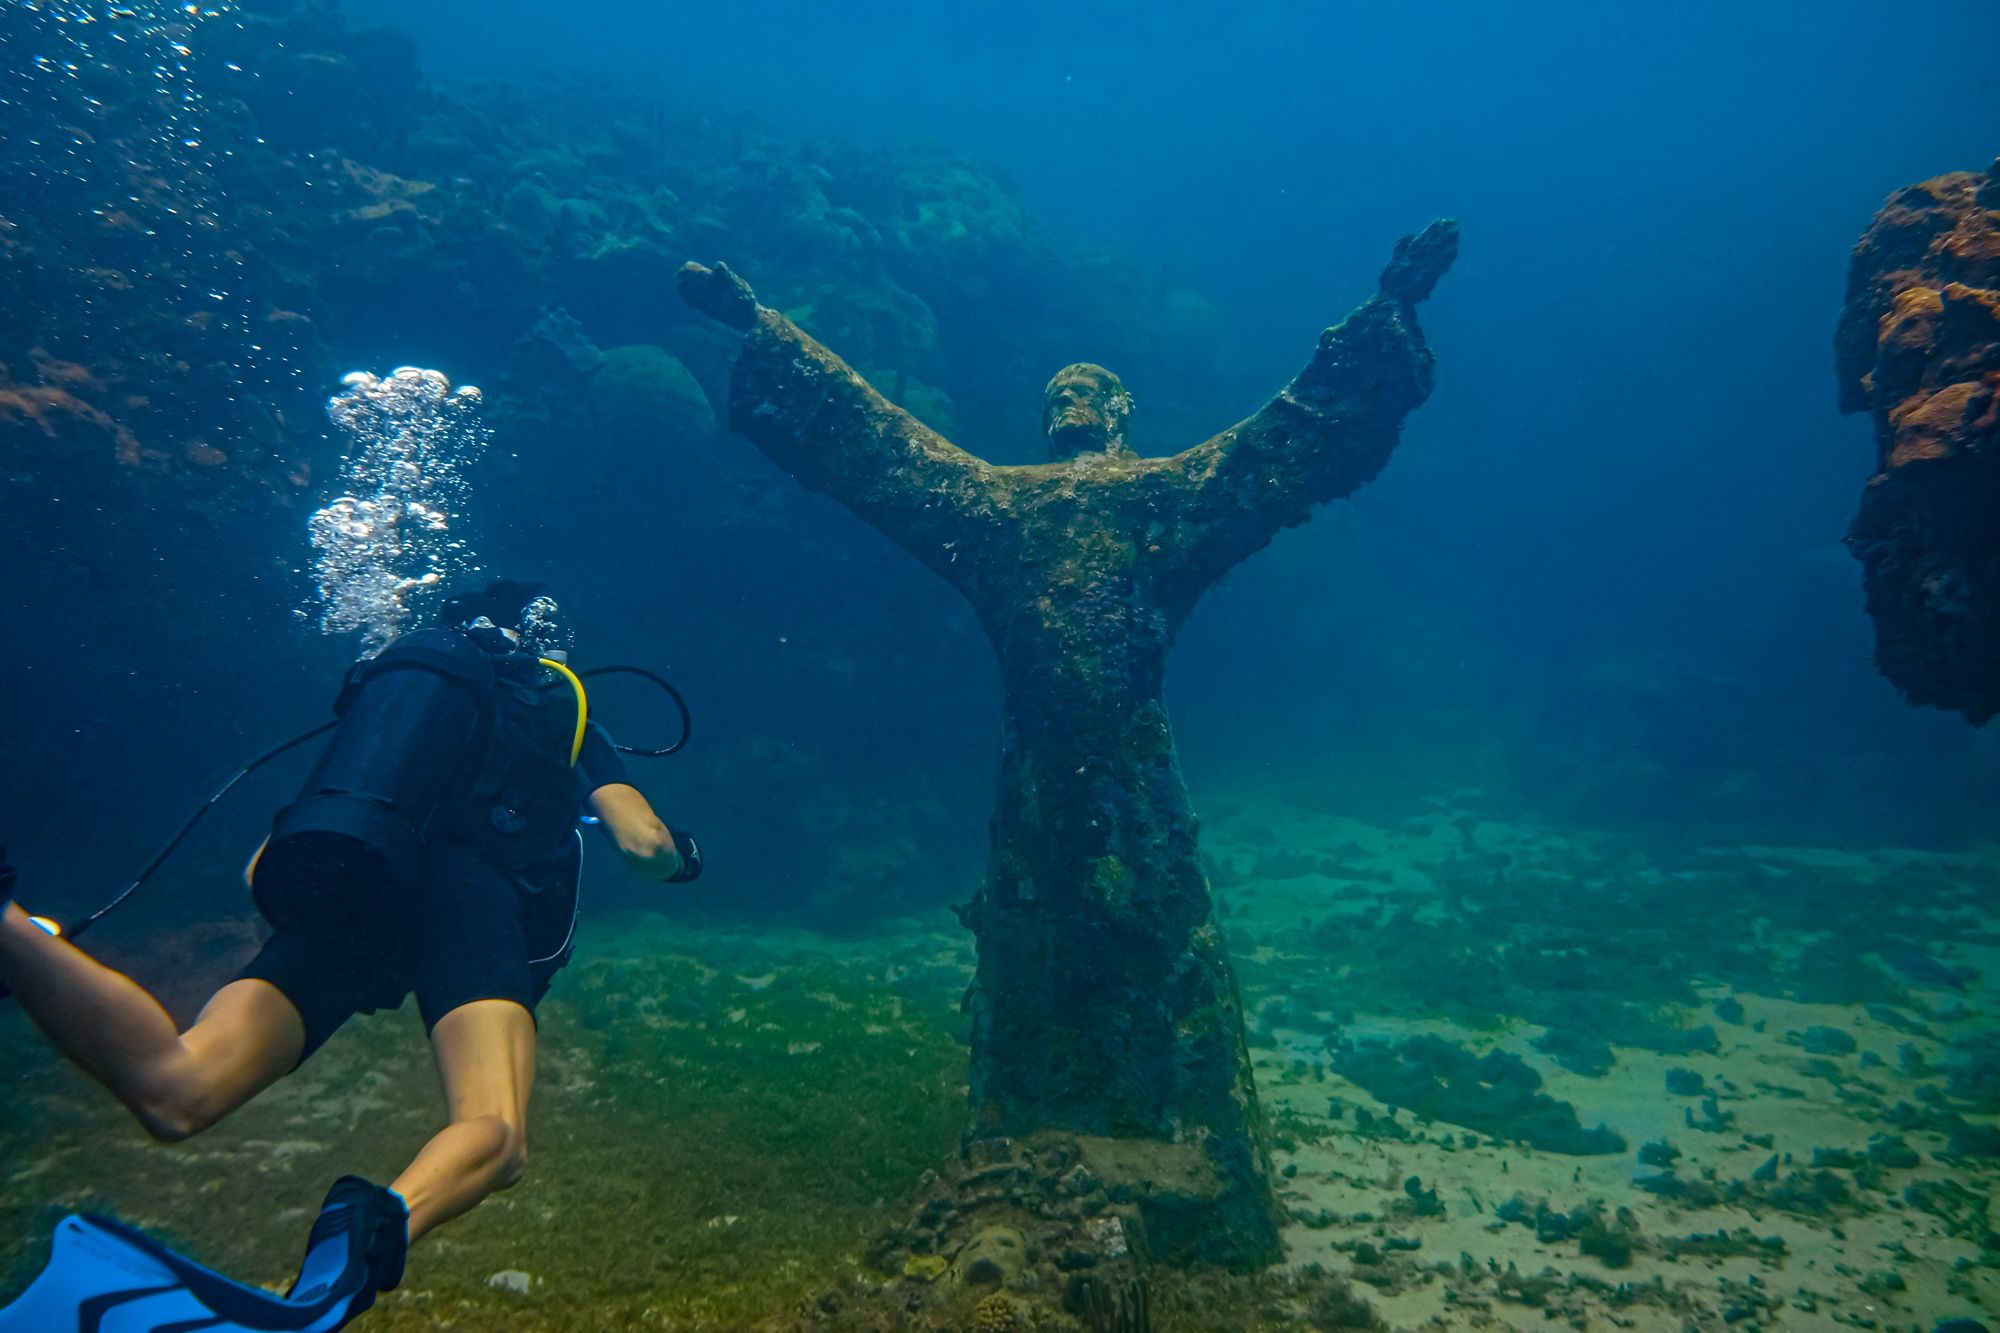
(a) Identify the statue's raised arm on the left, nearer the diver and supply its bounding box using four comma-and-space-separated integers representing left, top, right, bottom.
680, 264, 998, 582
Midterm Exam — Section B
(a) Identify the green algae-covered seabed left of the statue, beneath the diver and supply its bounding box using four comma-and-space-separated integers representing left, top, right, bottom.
0, 923, 964, 1333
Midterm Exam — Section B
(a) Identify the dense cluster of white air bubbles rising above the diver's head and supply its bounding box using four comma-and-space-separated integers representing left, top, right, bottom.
308, 366, 492, 654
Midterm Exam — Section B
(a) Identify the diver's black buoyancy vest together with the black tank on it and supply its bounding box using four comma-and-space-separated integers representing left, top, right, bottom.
250, 628, 582, 933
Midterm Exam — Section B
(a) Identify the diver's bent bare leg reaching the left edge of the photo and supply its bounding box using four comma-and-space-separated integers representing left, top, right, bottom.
0, 905, 306, 1143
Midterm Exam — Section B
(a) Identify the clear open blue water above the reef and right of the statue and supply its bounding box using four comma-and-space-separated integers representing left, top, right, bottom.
332, 0, 2000, 841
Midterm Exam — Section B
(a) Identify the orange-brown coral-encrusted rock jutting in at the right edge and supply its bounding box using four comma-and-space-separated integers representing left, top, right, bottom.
1834, 162, 2000, 725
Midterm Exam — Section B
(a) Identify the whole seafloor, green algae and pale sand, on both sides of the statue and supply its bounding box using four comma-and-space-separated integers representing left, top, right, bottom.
0, 791, 2000, 1333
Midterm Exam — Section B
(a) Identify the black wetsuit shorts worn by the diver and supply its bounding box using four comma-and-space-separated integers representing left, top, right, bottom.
238, 843, 580, 1063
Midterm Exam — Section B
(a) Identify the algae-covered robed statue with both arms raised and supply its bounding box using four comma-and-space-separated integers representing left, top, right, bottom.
680, 222, 1458, 1267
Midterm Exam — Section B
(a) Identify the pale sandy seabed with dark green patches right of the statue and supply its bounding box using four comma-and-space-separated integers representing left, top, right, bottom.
1204, 801, 2000, 1333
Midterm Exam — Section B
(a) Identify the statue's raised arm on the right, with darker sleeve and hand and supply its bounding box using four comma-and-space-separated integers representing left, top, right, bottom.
1172, 220, 1458, 580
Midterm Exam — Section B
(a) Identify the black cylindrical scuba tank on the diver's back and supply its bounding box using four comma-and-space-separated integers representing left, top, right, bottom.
250, 630, 498, 933
